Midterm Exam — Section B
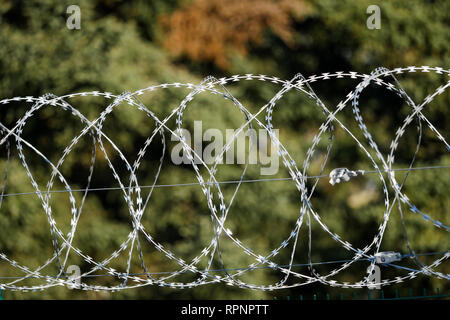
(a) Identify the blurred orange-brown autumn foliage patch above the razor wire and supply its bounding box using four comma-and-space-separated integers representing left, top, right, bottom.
159, 0, 309, 69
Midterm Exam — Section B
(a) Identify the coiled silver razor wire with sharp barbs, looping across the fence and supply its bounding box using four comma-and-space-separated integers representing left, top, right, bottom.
0, 66, 450, 291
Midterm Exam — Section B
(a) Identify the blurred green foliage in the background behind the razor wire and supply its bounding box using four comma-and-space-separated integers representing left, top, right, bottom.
0, 0, 450, 299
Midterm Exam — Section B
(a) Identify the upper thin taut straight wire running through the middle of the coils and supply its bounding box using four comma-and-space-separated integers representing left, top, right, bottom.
0, 165, 450, 198
